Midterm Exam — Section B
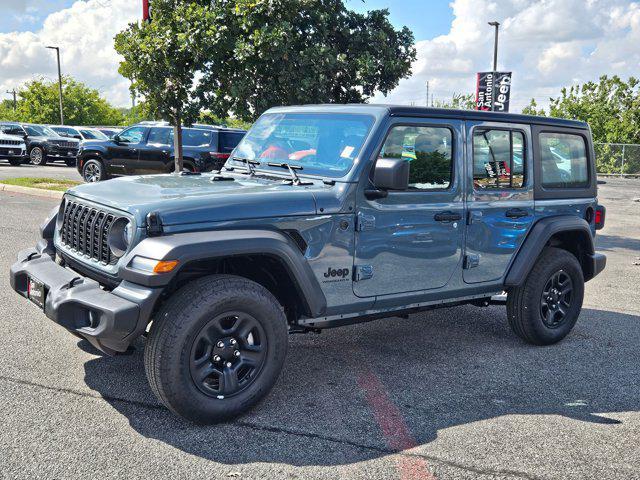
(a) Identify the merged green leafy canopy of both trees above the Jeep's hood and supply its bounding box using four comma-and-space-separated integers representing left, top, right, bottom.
116, 0, 416, 127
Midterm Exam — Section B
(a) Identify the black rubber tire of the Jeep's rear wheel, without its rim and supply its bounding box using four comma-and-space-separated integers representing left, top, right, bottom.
507, 247, 584, 345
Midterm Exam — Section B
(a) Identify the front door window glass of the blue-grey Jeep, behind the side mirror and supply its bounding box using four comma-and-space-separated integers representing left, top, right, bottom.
379, 125, 453, 190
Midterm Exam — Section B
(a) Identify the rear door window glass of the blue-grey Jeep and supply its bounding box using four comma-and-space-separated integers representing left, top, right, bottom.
473, 129, 526, 190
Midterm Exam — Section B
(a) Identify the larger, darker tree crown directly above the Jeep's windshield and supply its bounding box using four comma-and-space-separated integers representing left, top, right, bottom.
198, 0, 416, 121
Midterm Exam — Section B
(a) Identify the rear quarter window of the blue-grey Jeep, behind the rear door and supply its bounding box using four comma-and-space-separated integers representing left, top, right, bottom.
540, 133, 589, 188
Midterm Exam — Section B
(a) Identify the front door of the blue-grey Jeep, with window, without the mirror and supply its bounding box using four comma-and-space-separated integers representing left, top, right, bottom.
353, 118, 464, 297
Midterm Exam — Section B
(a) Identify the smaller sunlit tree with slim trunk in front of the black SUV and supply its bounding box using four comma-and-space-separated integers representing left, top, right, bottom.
115, 0, 215, 172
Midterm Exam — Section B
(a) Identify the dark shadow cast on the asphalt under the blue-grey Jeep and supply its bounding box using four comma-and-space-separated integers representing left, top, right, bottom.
81, 306, 640, 466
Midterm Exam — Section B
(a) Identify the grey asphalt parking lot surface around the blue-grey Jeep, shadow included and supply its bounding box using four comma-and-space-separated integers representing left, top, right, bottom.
0, 177, 640, 480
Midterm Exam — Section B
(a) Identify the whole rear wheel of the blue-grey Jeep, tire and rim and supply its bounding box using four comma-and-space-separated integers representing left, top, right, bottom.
507, 247, 584, 345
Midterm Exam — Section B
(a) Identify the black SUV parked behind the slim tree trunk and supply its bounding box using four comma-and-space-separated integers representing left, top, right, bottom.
77, 124, 246, 182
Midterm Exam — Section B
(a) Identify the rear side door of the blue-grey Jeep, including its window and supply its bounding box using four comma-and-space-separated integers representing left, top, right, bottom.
463, 122, 534, 283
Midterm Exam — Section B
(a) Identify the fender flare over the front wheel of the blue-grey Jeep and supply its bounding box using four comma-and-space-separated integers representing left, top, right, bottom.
118, 229, 327, 317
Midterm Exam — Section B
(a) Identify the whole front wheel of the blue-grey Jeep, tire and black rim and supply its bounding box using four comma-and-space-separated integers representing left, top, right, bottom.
144, 275, 288, 424
